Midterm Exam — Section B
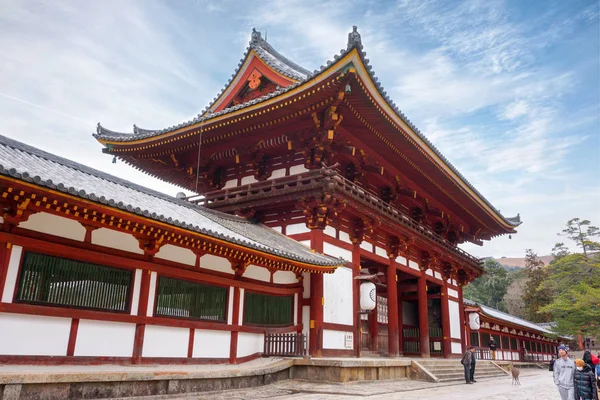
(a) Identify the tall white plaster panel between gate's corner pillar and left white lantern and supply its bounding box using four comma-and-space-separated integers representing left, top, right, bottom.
323, 267, 354, 325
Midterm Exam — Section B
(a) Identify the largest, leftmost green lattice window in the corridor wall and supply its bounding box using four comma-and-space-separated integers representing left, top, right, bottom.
15, 252, 133, 312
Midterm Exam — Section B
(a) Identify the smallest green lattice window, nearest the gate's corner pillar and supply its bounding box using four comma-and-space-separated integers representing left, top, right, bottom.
244, 291, 294, 326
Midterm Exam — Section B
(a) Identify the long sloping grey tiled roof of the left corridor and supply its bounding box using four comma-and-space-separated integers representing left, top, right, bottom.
0, 135, 345, 266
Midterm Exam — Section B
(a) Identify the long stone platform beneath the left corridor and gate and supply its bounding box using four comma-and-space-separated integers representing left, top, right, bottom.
0, 358, 544, 400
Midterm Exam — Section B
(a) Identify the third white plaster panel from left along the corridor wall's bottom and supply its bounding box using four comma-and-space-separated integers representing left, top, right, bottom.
142, 325, 190, 357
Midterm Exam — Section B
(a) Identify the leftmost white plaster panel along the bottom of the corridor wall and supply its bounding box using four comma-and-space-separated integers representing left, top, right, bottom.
0, 314, 71, 356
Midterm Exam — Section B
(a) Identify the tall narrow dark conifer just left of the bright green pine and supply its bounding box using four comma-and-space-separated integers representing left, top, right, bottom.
523, 249, 552, 322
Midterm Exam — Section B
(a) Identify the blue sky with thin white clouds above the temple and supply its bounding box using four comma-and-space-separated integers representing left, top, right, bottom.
0, 0, 600, 257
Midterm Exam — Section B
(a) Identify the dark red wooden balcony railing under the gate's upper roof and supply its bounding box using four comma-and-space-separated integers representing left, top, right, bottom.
188, 169, 481, 265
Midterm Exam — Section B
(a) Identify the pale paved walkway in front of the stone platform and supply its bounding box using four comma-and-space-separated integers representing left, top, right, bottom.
106, 370, 560, 400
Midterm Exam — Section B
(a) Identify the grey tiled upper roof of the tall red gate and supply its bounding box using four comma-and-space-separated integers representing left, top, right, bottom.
93, 26, 522, 227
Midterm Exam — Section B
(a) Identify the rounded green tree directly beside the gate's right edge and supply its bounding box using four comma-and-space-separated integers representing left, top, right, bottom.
464, 258, 510, 312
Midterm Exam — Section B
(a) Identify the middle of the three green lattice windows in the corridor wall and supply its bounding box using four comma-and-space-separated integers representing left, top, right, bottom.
155, 276, 227, 322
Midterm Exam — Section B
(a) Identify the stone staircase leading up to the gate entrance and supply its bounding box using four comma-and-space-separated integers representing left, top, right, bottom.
414, 359, 508, 382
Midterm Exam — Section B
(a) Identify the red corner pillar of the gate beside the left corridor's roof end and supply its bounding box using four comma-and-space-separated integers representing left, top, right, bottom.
309, 229, 325, 357
